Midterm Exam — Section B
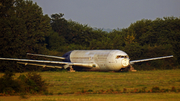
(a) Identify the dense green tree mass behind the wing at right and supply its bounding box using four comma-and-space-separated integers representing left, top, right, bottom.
119, 17, 180, 70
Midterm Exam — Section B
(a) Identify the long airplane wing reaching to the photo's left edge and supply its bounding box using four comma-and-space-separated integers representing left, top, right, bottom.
0, 58, 95, 69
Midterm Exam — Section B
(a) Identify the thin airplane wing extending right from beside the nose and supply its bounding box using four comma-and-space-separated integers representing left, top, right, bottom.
130, 55, 173, 64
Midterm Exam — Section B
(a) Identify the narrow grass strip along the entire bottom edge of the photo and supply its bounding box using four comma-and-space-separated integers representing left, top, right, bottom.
0, 93, 180, 101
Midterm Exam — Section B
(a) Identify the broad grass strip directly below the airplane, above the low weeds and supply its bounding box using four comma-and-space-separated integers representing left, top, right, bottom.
0, 69, 180, 94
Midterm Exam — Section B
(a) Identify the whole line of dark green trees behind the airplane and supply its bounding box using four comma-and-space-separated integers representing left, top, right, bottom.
0, 0, 180, 72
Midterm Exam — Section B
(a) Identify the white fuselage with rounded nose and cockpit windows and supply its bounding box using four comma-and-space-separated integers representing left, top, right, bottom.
69, 50, 129, 71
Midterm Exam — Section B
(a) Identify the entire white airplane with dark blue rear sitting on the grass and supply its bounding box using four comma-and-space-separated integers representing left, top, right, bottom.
0, 50, 173, 72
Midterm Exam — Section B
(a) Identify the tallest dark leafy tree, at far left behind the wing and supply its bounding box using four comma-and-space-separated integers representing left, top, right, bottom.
0, 0, 51, 71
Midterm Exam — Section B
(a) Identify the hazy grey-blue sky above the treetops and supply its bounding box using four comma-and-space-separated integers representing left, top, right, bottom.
32, 0, 180, 29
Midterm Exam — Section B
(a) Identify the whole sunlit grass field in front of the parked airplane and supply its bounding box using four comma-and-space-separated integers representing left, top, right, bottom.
0, 69, 180, 101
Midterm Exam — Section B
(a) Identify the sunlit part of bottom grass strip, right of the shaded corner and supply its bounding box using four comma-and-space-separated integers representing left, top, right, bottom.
27, 93, 180, 101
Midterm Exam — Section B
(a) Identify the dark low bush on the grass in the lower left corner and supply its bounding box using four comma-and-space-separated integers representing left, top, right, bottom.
0, 72, 48, 95
